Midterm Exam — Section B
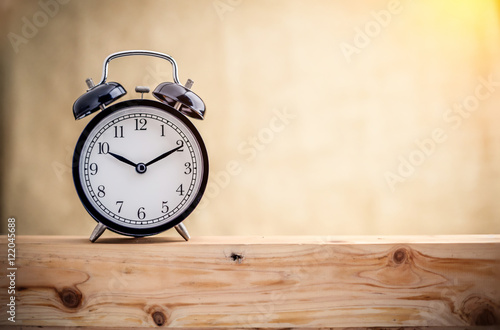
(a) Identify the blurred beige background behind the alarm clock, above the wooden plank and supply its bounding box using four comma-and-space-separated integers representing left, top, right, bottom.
0, 0, 500, 236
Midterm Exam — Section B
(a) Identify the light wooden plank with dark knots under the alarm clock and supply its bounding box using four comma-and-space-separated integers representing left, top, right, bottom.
0, 235, 500, 329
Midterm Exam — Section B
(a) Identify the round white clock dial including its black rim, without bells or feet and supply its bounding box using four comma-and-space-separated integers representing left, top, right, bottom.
73, 100, 208, 236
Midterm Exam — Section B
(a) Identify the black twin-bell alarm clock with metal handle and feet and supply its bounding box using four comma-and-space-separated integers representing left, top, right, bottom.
73, 50, 208, 242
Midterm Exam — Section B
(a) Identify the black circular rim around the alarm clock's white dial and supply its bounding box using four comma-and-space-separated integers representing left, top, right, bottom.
73, 99, 209, 237
